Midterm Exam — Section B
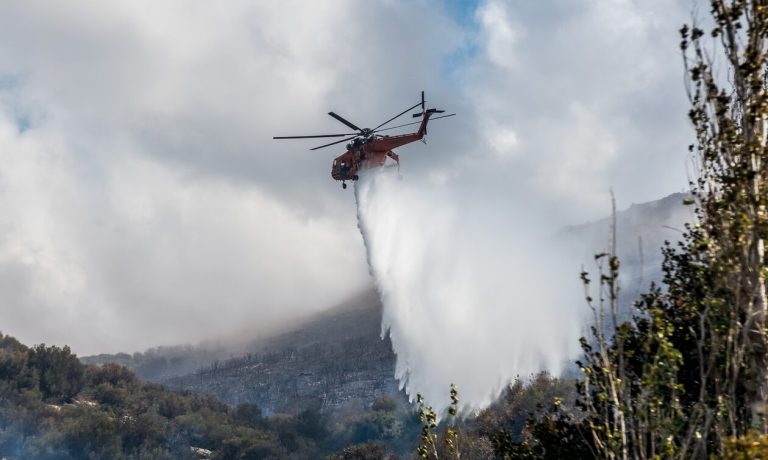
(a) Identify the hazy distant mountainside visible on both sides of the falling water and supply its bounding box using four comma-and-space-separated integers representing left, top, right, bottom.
83, 194, 690, 414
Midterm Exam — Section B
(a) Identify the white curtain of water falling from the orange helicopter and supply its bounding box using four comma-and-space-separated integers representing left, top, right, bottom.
356, 169, 583, 410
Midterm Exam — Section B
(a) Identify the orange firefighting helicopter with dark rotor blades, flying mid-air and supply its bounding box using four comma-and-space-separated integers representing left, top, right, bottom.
272, 91, 456, 189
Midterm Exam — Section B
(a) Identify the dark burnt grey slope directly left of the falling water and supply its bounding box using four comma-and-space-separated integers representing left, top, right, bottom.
164, 291, 398, 413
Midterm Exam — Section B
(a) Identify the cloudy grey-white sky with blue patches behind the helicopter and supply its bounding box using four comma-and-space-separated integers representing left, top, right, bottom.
0, 0, 697, 354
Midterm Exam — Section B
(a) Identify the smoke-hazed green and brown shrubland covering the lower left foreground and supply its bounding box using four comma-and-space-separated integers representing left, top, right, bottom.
0, 334, 426, 460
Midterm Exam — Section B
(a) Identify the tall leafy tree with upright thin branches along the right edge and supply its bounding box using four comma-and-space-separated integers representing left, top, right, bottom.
581, 0, 768, 459
